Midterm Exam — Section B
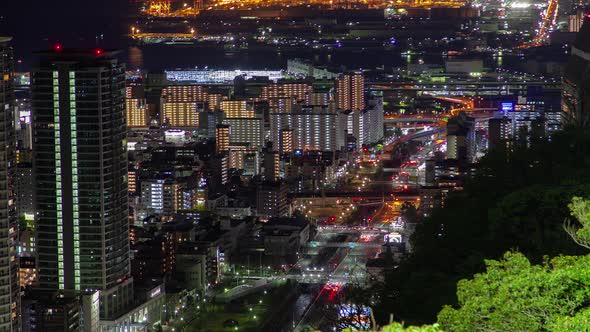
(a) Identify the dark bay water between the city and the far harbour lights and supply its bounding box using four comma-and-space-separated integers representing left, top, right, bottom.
0, 0, 524, 71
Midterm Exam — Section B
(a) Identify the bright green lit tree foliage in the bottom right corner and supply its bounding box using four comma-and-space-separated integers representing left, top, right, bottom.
438, 252, 590, 332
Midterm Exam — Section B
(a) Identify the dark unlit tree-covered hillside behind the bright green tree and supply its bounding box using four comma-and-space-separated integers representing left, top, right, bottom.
375, 128, 590, 325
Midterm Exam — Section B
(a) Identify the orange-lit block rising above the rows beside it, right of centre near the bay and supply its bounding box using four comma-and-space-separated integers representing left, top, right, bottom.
335, 72, 365, 111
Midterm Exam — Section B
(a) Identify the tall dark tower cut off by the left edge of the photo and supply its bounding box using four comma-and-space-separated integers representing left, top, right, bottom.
0, 37, 20, 331
